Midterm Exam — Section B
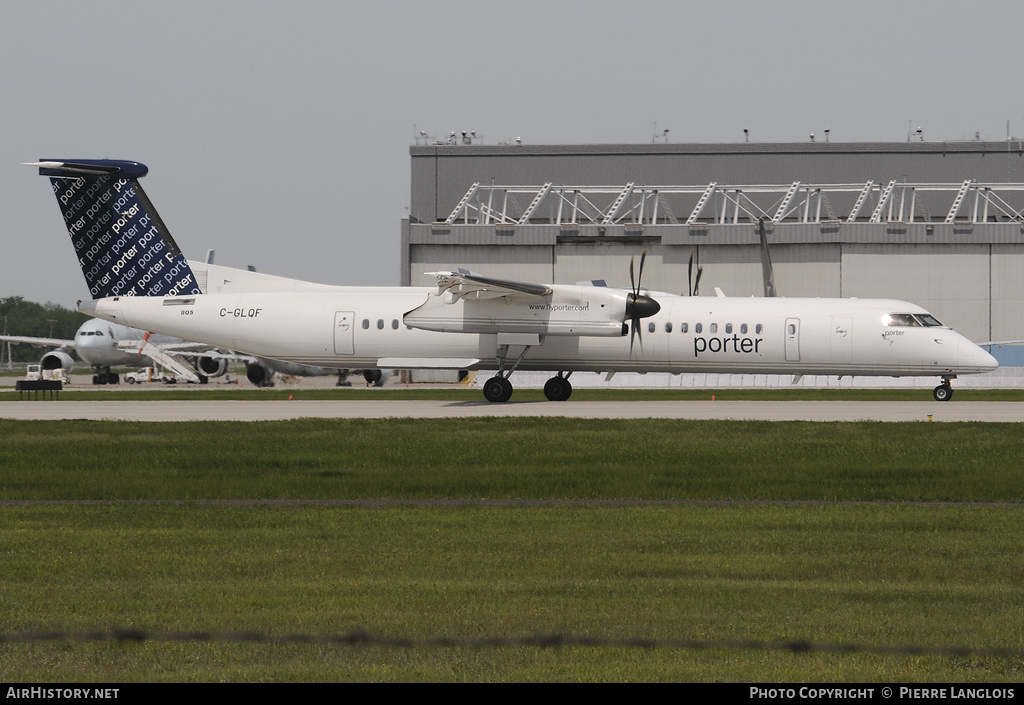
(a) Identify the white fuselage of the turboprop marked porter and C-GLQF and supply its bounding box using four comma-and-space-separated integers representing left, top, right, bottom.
82, 287, 996, 377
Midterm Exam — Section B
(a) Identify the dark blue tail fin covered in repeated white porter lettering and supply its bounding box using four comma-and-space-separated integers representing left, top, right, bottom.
30, 159, 203, 299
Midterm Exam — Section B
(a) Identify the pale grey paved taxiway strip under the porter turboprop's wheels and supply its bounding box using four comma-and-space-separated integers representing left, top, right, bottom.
0, 400, 1024, 422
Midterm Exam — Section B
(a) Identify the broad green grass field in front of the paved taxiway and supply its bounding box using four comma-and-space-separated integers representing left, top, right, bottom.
0, 419, 1024, 682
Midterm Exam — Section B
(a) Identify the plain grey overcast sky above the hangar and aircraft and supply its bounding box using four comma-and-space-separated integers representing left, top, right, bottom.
0, 0, 1024, 306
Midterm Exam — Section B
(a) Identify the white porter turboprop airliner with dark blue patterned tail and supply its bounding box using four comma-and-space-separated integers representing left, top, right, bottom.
33, 160, 997, 402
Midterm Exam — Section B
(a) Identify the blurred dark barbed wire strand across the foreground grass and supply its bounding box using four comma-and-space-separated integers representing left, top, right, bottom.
0, 629, 1024, 659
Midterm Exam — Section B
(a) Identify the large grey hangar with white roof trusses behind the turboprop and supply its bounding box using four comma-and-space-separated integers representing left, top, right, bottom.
401, 139, 1024, 358
